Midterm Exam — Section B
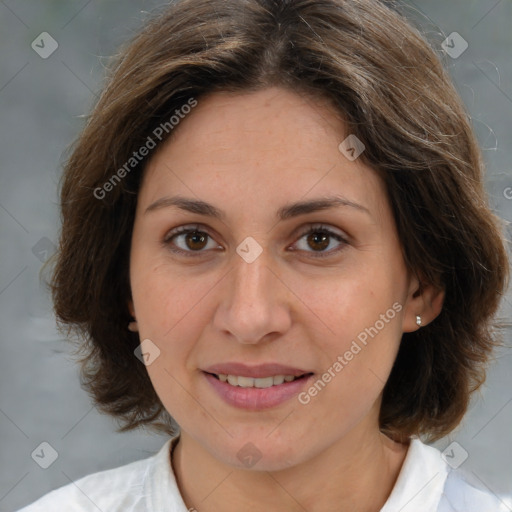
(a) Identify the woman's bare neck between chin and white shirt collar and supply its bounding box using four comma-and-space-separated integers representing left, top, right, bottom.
172, 429, 408, 512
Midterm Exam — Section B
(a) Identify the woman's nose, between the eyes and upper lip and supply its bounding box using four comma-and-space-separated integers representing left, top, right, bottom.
214, 243, 291, 344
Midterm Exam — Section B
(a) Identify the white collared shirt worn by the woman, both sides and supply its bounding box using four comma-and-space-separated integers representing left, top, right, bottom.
18, 437, 511, 512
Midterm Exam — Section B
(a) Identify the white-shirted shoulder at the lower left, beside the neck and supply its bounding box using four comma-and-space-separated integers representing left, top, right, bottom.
18, 440, 176, 512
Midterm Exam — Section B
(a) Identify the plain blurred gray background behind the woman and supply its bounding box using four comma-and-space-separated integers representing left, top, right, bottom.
0, 0, 512, 511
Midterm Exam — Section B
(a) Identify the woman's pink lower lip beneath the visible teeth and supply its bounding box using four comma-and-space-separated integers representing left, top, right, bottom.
203, 372, 313, 411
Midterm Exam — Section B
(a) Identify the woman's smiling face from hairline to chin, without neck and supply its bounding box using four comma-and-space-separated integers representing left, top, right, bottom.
130, 88, 421, 470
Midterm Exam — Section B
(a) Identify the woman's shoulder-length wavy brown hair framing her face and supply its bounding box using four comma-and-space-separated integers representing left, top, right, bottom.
52, 0, 508, 440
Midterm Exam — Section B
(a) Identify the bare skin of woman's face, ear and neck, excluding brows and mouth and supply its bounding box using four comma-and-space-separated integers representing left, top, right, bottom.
129, 88, 443, 512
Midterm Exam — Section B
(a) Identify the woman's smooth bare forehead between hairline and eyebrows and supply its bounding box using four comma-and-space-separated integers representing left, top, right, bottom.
139, 88, 385, 222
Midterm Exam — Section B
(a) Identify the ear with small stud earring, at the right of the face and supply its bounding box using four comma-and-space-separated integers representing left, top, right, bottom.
402, 275, 445, 332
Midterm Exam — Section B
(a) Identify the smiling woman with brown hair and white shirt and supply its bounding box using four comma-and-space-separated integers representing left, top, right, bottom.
19, 0, 508, 512
